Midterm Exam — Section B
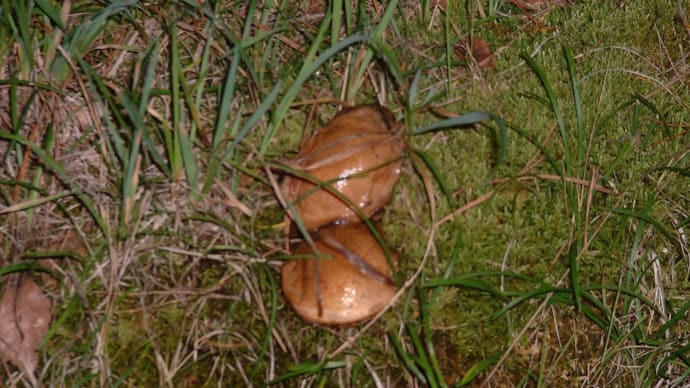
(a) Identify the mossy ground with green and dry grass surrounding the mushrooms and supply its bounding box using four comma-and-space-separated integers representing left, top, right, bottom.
0, 0, 690, 386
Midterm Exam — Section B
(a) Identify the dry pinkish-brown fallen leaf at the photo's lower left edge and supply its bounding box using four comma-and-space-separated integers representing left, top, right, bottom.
0, 277, 51, 376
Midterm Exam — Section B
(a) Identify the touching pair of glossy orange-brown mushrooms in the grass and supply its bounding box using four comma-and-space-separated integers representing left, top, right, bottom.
281, 105, 405, 326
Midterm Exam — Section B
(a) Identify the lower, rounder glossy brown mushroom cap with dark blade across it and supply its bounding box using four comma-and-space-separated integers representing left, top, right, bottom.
281, 223, 397, 326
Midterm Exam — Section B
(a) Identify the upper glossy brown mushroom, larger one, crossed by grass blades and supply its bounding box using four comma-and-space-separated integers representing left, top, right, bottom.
282, 105, 404, 229
